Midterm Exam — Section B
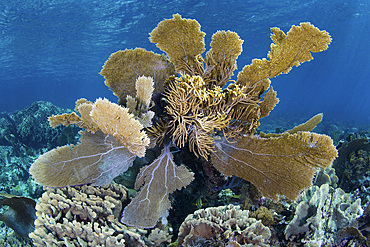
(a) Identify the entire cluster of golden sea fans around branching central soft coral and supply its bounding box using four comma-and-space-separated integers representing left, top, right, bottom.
30, 14, 337, 228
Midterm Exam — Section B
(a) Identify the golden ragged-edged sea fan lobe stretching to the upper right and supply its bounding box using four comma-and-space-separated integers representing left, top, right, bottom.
237, 22, 331, 87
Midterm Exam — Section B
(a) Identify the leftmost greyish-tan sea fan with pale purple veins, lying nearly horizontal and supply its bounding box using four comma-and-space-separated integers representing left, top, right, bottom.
30, 130, 136, 187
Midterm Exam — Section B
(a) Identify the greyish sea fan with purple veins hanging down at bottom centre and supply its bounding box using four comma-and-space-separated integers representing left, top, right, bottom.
121, 146, 194, 228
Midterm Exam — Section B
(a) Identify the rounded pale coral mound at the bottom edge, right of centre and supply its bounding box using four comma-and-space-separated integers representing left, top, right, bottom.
177, 204, 271, 246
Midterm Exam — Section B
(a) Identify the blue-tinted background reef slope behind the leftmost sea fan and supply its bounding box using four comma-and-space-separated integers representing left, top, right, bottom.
0, 101, 78, 198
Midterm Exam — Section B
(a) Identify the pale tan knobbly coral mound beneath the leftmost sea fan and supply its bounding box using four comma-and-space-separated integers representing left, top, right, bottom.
30, 183, 171, 247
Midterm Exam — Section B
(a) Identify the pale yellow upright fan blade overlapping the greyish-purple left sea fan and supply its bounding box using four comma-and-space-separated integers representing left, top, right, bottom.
90, 98, 150, 157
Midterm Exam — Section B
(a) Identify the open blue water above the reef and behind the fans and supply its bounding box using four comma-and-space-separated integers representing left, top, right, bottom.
0, 0, 370, 125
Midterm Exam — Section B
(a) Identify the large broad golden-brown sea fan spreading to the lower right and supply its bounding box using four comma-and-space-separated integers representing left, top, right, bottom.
211, 132, 338, 200
